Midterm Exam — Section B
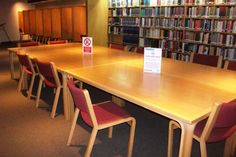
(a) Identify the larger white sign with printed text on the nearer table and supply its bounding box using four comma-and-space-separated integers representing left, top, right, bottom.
144, 47, 162, 74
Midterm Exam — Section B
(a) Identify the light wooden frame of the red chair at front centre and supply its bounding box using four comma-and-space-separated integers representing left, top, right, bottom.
67, 89, 136, 157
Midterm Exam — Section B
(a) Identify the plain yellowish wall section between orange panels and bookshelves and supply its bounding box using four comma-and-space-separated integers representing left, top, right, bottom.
87, 0, 108, 46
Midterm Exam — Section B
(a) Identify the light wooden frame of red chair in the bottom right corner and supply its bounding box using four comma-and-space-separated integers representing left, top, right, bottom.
168, 103, 236, 157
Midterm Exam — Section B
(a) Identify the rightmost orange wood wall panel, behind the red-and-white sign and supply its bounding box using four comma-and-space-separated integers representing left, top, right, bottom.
73, 6, 87, 41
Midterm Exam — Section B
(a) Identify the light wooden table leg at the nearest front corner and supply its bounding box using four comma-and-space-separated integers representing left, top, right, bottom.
179, 122, 195, 157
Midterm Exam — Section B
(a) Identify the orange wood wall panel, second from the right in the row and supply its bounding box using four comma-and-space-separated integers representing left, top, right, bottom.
61, 7, 73, 39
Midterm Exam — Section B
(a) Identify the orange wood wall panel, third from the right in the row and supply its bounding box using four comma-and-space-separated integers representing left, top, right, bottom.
51, 8, 61, 38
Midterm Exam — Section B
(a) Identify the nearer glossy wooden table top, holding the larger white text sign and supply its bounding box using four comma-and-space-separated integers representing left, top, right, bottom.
67, 58, 236, 124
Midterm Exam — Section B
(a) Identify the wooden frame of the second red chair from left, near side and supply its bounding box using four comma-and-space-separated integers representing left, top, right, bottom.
36, 62, 62, 118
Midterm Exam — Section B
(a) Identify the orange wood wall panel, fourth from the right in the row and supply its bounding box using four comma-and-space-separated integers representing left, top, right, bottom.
43, 9, 52, 37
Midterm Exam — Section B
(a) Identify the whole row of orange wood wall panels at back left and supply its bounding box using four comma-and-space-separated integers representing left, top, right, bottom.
19, 6, 87, 41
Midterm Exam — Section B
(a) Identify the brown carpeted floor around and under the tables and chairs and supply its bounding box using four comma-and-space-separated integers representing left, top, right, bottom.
0, 44, 229, 157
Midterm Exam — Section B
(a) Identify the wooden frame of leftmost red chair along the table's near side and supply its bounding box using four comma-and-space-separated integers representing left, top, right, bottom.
17, 54, 38, 99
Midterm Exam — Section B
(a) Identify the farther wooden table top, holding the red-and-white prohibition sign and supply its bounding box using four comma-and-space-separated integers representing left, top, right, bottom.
9, 43, 142, 70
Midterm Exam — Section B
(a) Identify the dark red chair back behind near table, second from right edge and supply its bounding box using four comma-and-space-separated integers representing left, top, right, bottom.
193, 53, 219, 67
